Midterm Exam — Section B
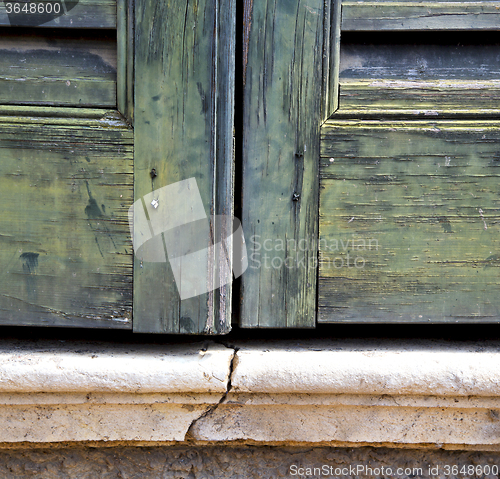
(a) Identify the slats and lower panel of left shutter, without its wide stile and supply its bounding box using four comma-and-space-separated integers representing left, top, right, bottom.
0, 0, 133, 328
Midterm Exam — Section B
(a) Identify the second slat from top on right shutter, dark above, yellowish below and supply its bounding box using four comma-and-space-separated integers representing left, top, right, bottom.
340, 40, 500, 115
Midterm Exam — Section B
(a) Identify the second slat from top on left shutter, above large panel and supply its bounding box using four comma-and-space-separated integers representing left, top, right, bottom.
0, 29, 116, 107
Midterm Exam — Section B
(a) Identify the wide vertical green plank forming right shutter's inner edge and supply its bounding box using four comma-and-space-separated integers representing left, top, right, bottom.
241, 0, 324, 328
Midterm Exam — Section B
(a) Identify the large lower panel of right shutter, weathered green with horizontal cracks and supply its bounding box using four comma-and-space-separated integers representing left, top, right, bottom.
319, 120, 500, 323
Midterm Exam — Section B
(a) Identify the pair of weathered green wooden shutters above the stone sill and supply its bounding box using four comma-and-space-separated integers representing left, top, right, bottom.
4, 0, 492, 334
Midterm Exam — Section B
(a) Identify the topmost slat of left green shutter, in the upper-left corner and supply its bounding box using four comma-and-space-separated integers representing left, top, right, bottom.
0, 0, 117, 29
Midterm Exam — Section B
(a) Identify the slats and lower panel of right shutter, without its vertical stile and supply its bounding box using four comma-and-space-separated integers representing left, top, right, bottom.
318, 1, 500, 323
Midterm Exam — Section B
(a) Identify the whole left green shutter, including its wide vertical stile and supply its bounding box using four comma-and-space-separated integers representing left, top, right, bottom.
0, 0, 235, 333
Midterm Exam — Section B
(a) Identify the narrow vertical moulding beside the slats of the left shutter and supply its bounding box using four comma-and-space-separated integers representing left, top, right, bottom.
116, 0, 134, 125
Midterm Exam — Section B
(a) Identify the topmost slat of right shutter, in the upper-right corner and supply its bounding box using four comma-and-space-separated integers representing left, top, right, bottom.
342, 0, 500, 31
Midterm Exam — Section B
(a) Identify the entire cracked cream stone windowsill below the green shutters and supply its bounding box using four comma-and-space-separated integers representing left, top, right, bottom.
0, 341, 500, 450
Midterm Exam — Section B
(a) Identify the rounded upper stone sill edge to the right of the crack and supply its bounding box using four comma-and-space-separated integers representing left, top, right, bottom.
232, 341, 500, 396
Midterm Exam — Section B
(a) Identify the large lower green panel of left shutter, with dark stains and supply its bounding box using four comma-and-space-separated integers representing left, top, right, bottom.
0, 107, 133, 329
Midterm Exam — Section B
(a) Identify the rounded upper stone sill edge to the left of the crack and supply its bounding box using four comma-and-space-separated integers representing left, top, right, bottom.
0, 341, 234, 393
